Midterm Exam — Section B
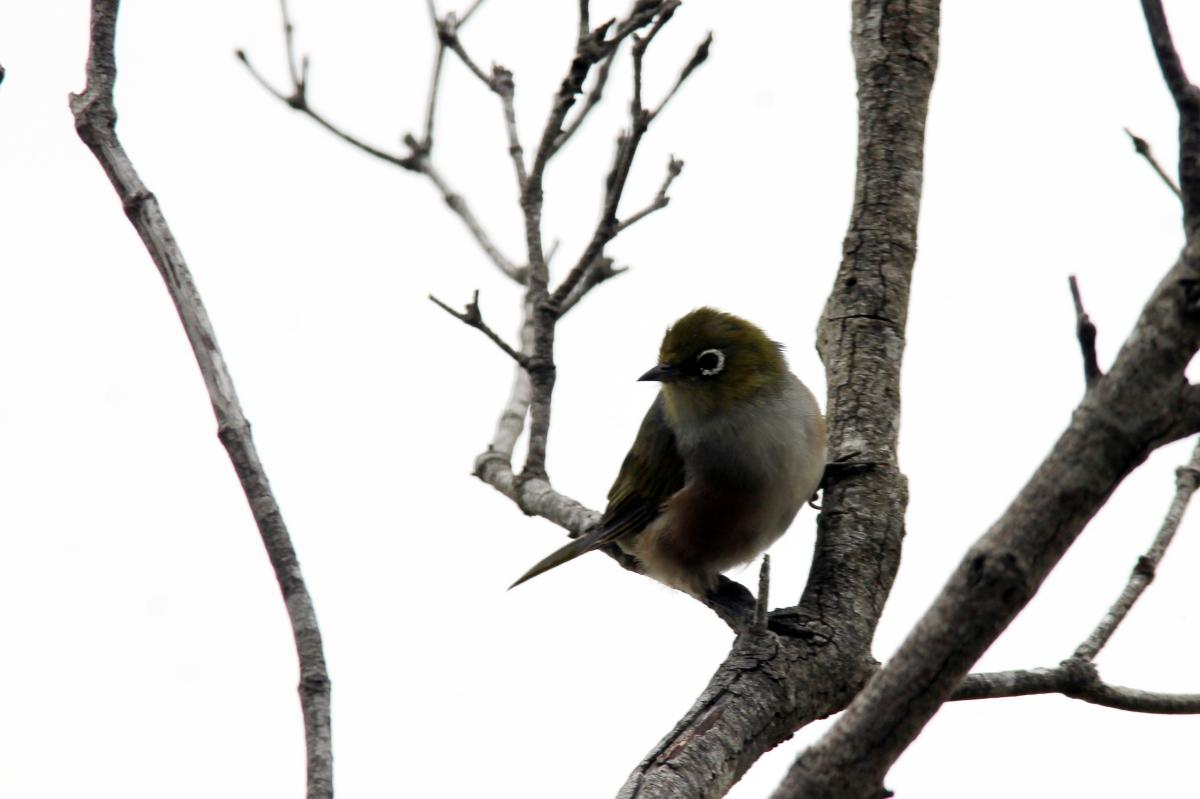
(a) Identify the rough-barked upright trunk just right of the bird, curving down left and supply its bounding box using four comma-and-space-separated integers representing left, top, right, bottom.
620, 0, 938, 798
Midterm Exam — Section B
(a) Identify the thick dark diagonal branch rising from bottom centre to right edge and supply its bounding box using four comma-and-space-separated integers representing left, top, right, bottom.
778, 221, 1200, 798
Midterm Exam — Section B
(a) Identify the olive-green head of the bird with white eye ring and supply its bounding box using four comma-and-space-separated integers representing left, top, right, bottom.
640, 308, 787, 415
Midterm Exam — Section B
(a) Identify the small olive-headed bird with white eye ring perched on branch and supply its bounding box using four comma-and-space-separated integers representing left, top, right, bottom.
512, 308, 826, 596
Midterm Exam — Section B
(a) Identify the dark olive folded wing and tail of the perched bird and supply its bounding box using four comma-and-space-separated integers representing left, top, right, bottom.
509, 392, 685, 588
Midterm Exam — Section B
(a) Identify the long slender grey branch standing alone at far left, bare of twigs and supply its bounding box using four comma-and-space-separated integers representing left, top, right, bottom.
71, 0, 334, 799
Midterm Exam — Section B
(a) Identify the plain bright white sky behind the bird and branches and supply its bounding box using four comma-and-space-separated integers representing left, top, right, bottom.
0, 0, 1200, 799
